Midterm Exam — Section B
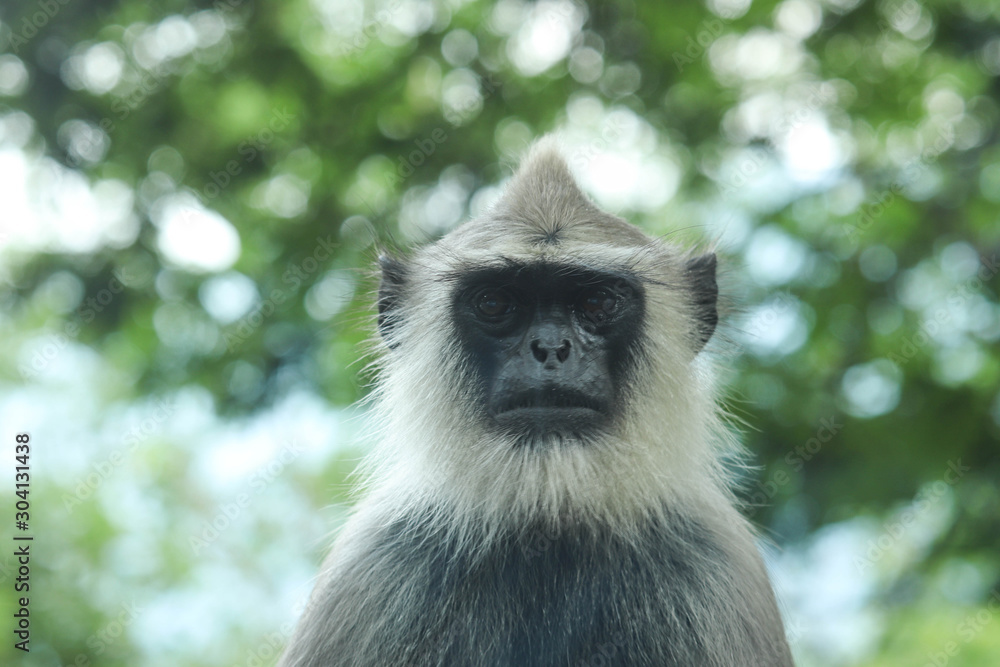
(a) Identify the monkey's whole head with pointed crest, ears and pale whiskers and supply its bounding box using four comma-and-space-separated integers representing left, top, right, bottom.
373, 145, 718, 521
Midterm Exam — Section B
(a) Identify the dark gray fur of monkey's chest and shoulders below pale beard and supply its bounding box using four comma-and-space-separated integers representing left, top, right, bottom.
284, 508, 791, 667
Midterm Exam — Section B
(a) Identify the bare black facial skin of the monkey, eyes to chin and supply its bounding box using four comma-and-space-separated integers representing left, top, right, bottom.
453, 264, 643, 438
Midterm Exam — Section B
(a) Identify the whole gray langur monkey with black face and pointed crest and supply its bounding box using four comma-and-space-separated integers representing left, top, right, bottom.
280, 141, 792, 667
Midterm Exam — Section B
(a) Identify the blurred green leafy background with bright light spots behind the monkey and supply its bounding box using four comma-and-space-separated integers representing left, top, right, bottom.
0, 0, 1000, 667
